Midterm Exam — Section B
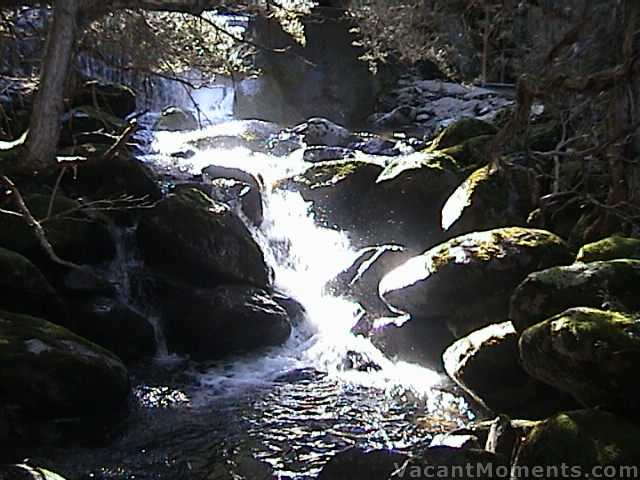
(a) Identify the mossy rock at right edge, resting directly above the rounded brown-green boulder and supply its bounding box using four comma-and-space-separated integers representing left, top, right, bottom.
509, 260, 640, 331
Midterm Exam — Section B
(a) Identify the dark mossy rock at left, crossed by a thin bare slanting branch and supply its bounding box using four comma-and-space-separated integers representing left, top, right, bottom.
0, 194, 115, 265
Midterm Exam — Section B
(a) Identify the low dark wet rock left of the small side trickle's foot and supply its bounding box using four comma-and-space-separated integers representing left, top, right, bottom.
63, 296, 156, 363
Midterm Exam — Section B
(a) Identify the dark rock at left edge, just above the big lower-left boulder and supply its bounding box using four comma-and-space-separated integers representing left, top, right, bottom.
0, 247, 66, 320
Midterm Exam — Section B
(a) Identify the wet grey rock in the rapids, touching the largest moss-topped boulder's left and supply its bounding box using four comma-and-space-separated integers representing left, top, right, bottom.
325, 245, 406, 316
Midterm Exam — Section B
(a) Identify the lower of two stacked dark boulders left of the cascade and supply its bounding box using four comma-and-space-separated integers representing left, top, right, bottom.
165, 285, 291, 360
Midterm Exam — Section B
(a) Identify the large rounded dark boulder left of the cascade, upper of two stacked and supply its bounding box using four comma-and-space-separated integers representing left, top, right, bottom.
138, 189, 271, 287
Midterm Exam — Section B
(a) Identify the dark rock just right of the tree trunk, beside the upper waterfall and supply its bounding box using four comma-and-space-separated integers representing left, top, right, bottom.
71, 80, 136, 120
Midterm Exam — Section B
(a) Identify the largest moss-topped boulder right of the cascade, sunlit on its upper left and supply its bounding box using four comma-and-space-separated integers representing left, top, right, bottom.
380, 227, 573, 338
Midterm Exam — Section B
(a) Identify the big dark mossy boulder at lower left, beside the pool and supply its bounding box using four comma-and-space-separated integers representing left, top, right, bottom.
0, 311, 129, 419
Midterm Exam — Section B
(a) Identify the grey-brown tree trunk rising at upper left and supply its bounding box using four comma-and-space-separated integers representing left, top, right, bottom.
27, 0, 80, 171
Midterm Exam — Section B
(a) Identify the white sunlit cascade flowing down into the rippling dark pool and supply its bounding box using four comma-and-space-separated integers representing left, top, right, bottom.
26, 109, 473, 480
